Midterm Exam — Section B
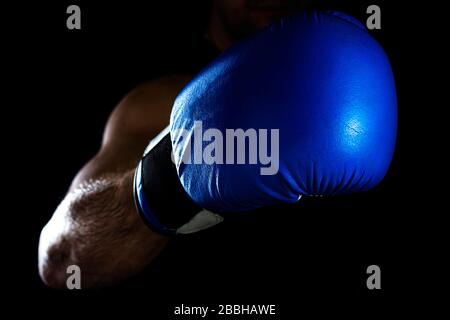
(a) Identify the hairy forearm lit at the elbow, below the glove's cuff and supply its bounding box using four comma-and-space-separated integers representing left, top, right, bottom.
39, 170, 167, 287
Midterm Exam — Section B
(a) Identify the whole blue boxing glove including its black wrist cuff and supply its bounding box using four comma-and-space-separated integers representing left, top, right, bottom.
135, 12, 397, 234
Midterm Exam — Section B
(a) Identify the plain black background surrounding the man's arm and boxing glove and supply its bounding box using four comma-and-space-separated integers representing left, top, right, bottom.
7, 0, 448, 319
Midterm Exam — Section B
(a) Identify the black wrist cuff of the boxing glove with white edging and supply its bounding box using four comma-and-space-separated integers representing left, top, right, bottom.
134, 129, 223, 235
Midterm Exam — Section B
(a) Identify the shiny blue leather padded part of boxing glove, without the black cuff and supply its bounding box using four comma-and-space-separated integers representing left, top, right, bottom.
171, 12, 397, 211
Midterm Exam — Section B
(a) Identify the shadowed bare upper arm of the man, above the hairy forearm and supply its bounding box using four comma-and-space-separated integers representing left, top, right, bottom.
72, 75, 189, 187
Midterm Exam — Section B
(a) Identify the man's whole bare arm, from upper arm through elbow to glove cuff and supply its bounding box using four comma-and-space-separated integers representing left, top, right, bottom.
39, 76, 189, 288
